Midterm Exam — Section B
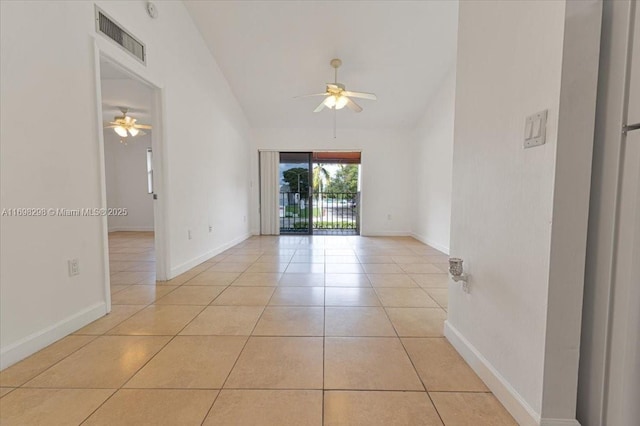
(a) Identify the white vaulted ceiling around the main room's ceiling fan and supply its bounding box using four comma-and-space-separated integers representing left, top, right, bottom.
185, 0, 458, 128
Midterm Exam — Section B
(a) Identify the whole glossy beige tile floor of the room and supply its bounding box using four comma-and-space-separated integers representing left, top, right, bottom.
0, 232, 516, 426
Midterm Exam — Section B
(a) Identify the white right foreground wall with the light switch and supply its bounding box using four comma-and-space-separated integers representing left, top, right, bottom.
446, 1, 601, 425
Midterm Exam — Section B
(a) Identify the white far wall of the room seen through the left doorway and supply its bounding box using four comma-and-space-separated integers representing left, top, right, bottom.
104, 129, 153, 232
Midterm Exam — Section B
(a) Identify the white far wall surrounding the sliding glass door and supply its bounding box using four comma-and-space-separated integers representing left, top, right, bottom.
252, 128, 416, 235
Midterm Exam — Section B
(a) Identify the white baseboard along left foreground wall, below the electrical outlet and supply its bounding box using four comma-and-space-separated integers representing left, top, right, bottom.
0, 302, 107, 370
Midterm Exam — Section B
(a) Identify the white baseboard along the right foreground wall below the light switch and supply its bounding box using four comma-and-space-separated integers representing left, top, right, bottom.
444, 321, 540, 426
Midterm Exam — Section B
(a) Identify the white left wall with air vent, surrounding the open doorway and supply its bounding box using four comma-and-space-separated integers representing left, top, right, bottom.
0, 1, 250, 367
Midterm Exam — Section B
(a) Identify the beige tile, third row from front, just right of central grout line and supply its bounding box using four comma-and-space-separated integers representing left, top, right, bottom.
325, 307, 396, 337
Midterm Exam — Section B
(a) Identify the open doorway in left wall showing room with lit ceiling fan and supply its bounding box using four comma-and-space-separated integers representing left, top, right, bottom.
98, 52, 167, 309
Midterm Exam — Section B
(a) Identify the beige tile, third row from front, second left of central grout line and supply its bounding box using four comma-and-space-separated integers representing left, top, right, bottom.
180, 306, 264, 336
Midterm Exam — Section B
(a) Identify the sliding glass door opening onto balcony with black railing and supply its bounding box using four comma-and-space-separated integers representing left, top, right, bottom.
278, 152, 361, 235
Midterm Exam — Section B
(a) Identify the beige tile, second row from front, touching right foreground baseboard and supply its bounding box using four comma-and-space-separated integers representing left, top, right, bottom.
402, 338, 489, 392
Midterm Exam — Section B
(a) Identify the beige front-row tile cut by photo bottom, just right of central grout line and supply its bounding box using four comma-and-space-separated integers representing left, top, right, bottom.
324, 391, 442, 426
